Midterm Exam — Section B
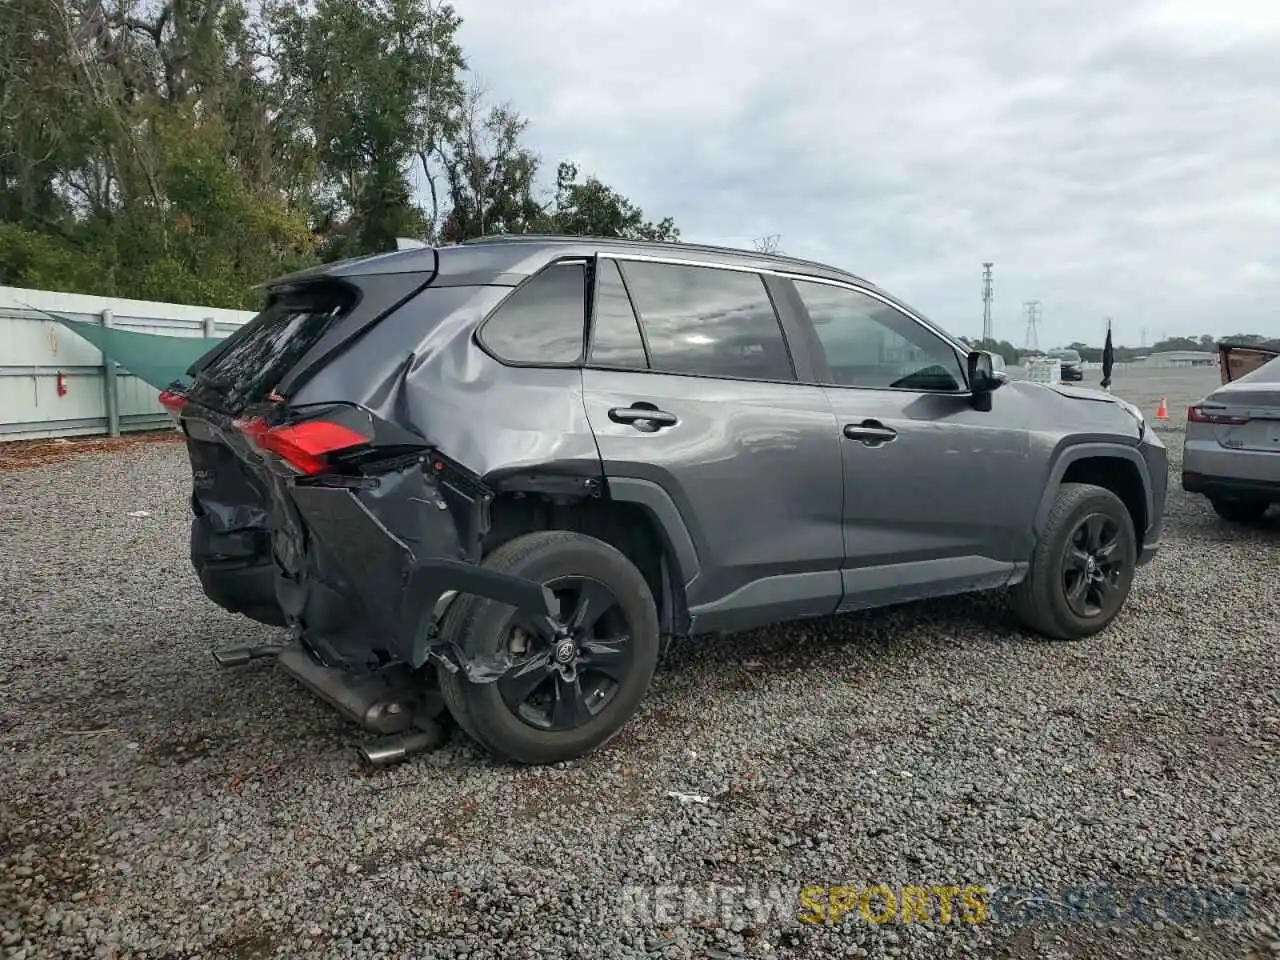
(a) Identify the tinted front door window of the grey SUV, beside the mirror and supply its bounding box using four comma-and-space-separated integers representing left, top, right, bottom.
796, 280, 964, 390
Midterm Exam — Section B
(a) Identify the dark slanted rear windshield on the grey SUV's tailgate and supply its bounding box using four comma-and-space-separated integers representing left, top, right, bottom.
196, 284, 356, 410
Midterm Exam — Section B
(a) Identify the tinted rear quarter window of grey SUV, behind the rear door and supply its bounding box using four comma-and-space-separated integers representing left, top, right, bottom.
480, 264, 586, 364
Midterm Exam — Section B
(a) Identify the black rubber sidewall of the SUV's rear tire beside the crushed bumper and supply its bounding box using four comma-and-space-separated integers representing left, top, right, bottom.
450, 538, 659, 762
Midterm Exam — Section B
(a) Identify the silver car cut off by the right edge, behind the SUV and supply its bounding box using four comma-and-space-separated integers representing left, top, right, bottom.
1183, 357, 1280, 521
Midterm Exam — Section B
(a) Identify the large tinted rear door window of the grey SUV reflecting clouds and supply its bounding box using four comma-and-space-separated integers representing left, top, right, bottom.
622, 261, 795, 380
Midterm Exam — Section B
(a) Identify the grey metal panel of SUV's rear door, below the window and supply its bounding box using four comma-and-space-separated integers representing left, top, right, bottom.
582, 369, 844, 607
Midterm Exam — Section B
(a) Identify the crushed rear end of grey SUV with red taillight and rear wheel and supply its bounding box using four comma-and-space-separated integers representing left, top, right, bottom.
161, 247, 658, 763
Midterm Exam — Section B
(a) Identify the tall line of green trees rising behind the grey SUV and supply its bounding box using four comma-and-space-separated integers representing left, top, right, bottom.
0, 0, 677, 306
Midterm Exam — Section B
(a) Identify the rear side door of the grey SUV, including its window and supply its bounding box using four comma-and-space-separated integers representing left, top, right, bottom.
582, 255, 844, 640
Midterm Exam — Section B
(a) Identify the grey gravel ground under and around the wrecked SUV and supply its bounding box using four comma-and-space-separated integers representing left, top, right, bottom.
0, 371, 1280, 960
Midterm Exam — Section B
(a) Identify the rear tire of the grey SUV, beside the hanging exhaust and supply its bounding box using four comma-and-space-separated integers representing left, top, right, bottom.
439, 530, 659, 764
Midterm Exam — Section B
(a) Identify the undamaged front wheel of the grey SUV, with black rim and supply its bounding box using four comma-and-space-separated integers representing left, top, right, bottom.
1011, 484, 1138, 640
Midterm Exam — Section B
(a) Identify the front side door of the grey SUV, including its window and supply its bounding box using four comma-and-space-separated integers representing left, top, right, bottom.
778, 278, 1041, 609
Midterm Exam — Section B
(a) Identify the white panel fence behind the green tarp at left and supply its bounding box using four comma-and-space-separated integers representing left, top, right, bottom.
0, 287, 253, 442
